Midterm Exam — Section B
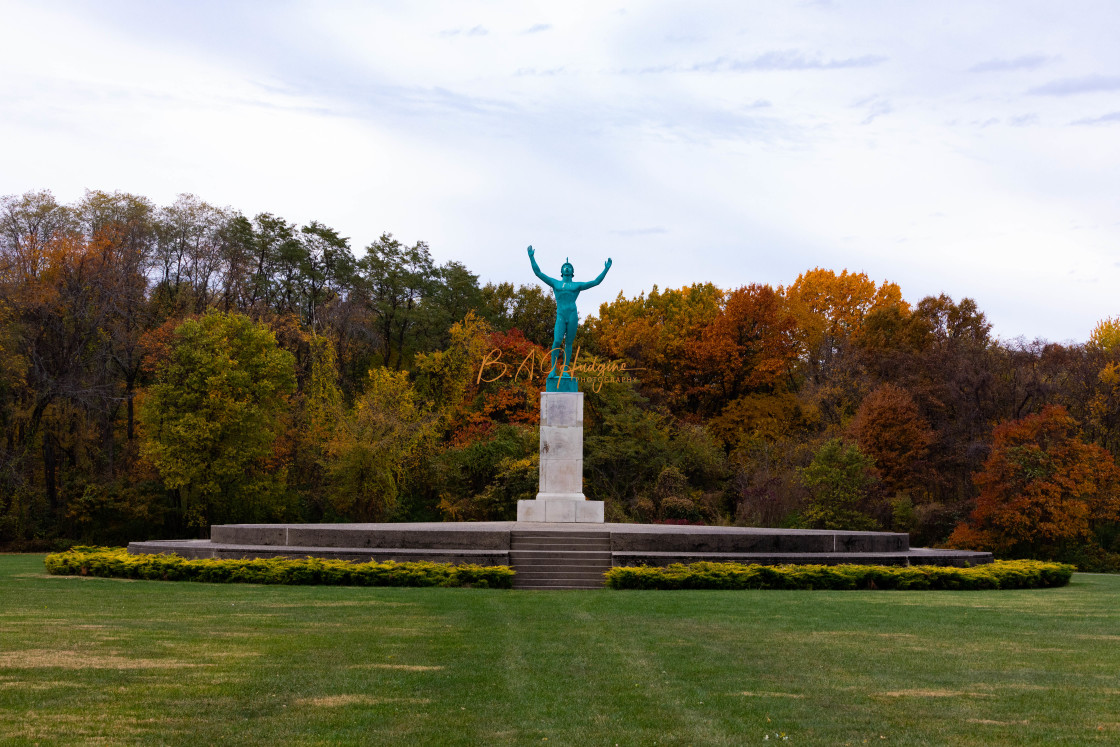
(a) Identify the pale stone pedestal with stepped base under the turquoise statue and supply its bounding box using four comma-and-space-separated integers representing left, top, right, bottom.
517, 392, 603, 524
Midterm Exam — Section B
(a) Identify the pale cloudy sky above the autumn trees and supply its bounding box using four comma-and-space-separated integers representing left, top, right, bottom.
0, 0, 1120, 340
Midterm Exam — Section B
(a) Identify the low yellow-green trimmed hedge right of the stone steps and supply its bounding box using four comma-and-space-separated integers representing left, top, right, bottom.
606, 560, 1074, 590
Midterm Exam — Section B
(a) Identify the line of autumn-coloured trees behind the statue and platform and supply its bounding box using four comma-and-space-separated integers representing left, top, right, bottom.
0, 192, 1120, 568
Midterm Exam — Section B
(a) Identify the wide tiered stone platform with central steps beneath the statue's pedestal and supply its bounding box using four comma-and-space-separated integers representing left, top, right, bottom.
129, 522, 992, 588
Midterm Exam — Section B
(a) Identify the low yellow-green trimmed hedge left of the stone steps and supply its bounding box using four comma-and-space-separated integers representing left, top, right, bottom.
44, 547, 513, 589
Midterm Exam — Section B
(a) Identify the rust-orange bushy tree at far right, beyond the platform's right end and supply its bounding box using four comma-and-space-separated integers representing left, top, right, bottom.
949, 407, 1120, 558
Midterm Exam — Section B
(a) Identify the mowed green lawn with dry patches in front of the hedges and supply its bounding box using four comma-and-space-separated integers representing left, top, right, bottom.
0, 555, 1120, 746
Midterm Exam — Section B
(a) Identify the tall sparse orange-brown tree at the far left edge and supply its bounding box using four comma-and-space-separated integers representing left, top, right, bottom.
0, 202, 128, 521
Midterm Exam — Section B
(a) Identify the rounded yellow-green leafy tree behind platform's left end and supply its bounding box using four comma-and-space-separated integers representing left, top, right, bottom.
140, 312, 296, 527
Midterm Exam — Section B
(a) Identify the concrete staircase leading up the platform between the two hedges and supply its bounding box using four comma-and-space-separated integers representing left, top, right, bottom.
510, 530, 612, 589
